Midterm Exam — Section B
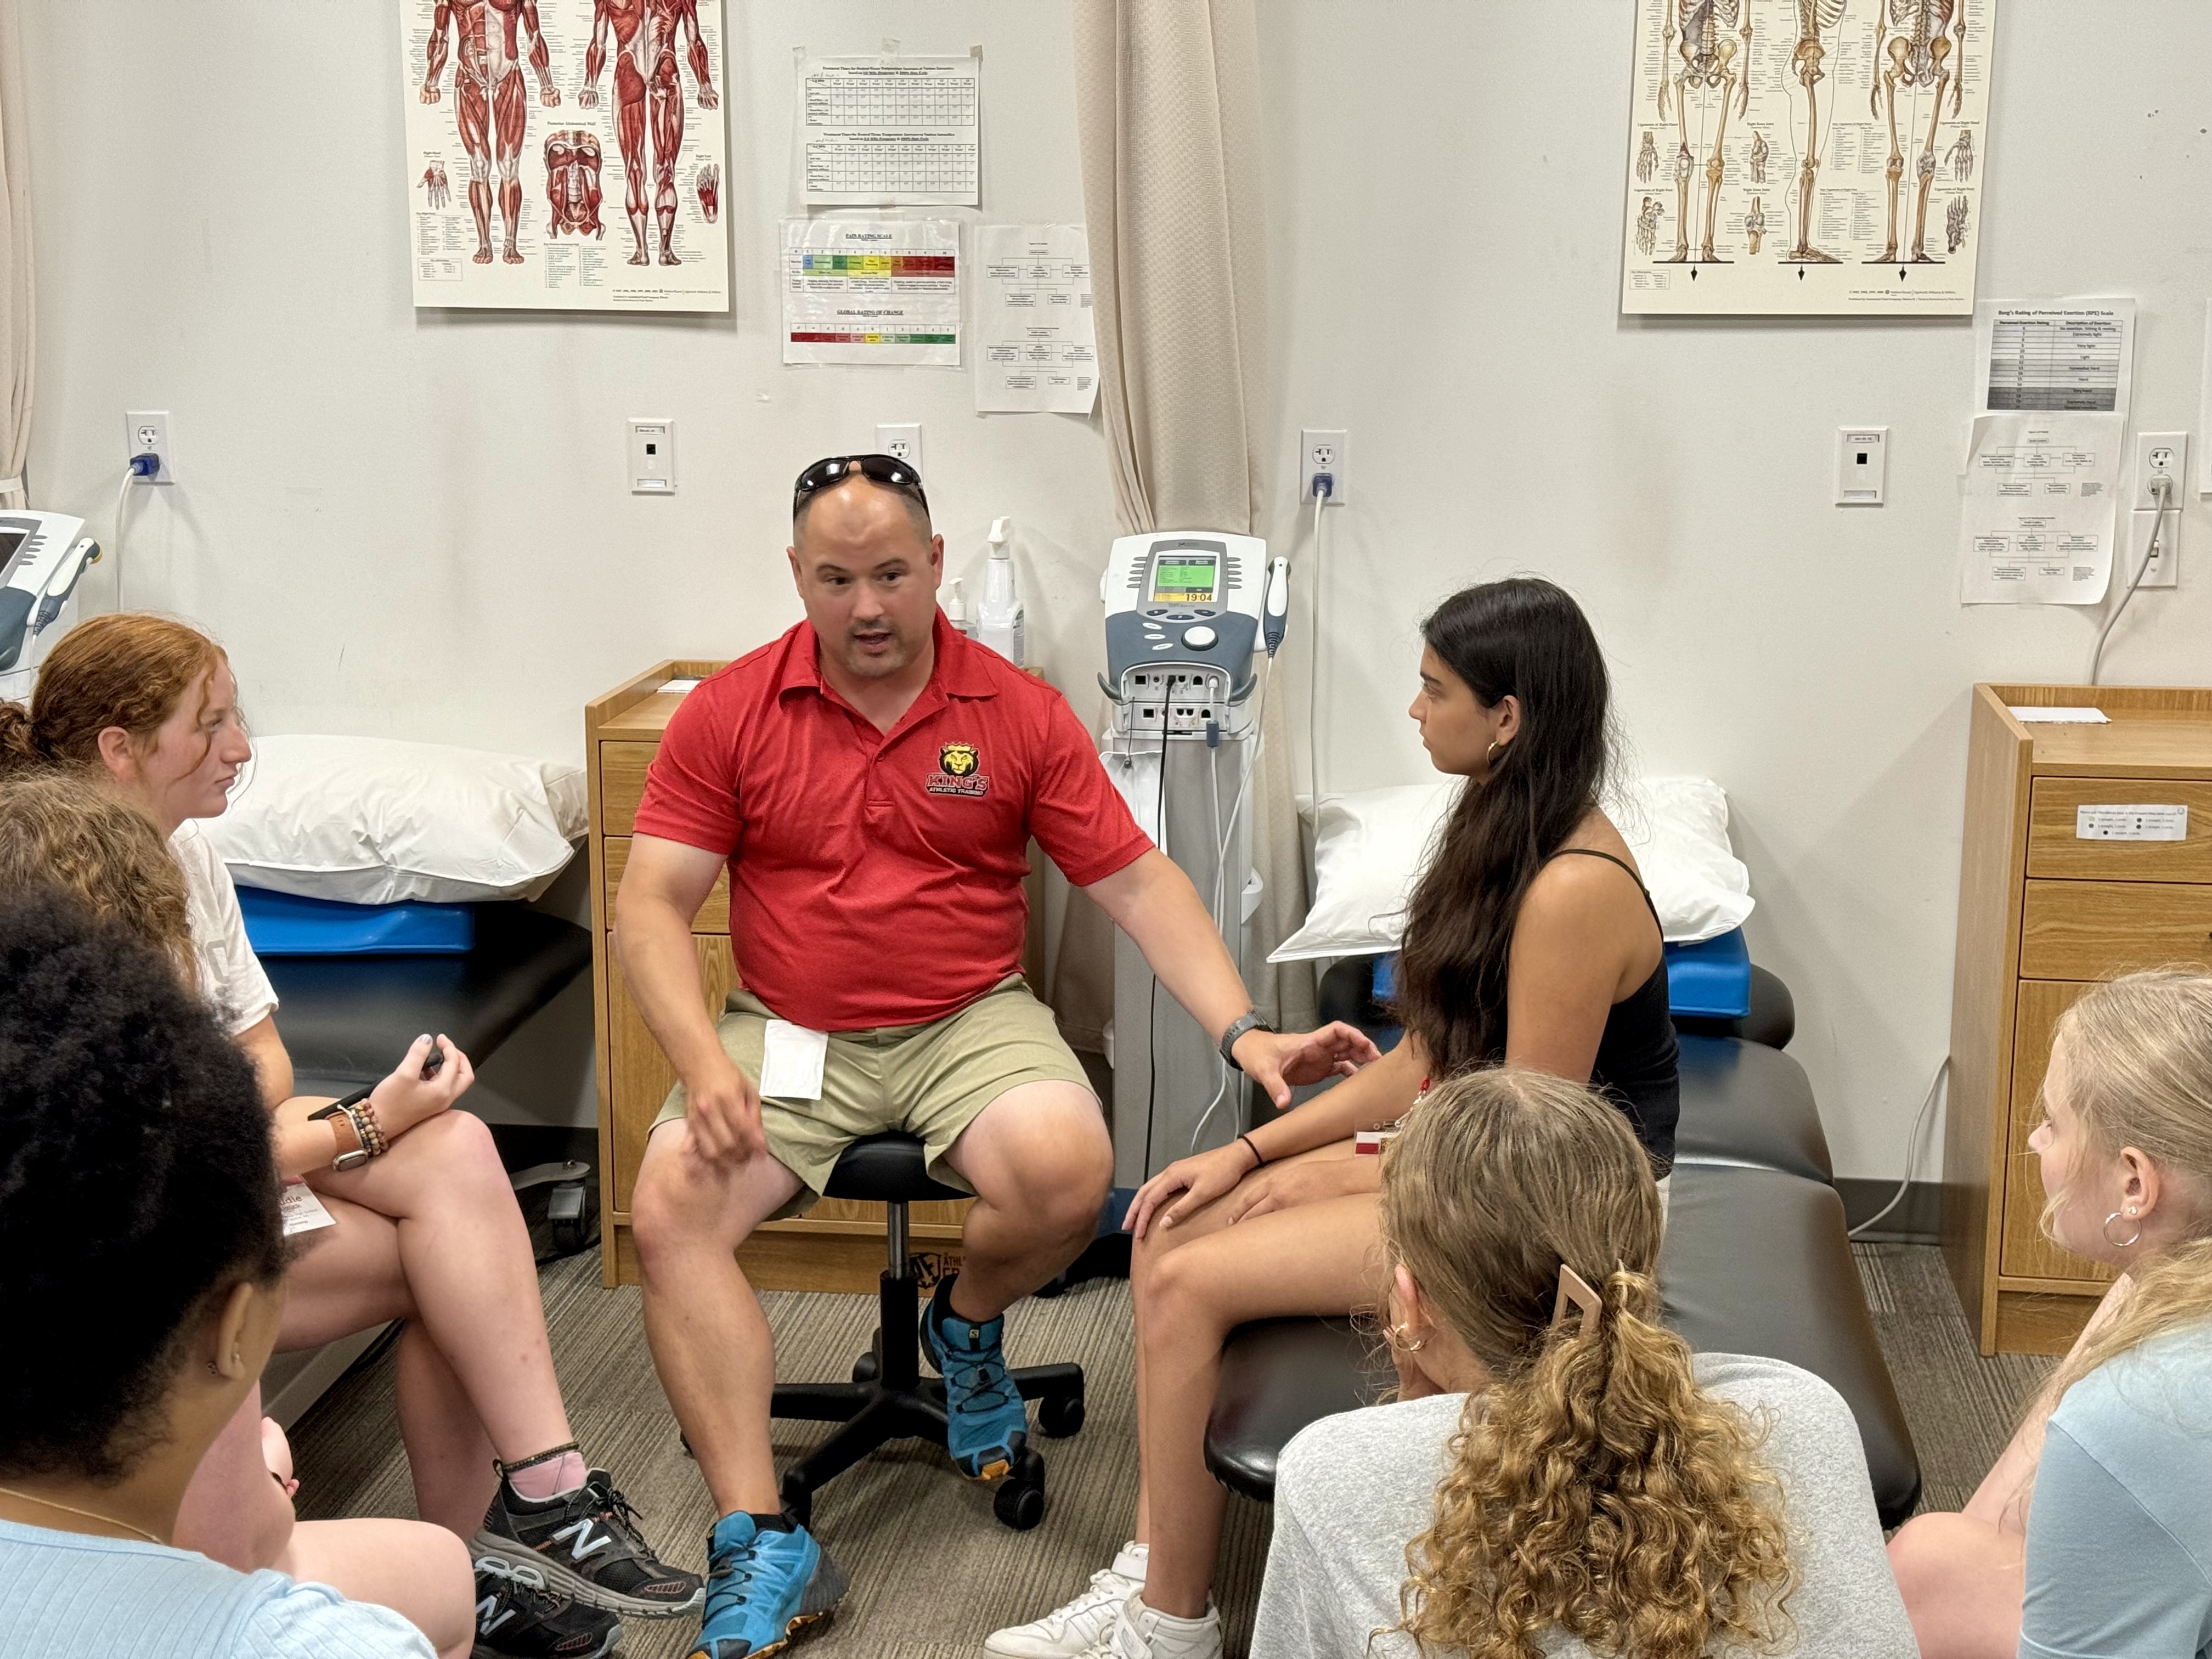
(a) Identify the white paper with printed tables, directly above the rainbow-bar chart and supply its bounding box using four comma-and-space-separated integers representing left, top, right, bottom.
799, 53, 982, 208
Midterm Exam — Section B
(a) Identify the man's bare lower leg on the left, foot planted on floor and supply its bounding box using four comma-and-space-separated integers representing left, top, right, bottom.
630, 1124, 801, 1515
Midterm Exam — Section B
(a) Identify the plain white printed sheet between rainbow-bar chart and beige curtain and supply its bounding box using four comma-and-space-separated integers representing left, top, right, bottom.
975, 225, 1099, 414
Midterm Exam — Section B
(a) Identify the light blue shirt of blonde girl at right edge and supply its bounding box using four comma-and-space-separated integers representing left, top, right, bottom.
2019, 1325, 2212, 1659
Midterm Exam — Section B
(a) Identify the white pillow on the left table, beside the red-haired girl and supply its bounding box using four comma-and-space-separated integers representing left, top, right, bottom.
206, 737, 586, 905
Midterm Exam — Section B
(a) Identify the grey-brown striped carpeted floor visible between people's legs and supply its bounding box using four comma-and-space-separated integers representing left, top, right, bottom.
292, 1245, 2051, 1659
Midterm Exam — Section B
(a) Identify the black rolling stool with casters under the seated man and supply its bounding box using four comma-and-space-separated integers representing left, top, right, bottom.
768, 1130, 1084, 1533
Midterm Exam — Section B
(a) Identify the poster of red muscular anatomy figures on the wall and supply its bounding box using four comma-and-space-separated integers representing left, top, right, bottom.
398, 0, 730, 312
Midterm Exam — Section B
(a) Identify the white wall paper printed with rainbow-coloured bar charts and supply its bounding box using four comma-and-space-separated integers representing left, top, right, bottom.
783, 219, 960, 367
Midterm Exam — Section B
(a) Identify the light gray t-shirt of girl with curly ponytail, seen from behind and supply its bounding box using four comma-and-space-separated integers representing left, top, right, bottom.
1252, 1354, 1920, 1659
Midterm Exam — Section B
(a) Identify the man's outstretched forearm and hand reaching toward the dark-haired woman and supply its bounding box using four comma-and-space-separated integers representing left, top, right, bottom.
1084, 847, 1376, 1108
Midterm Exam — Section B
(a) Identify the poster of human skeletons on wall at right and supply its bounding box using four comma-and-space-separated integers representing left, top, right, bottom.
1621, 0, 1997, 317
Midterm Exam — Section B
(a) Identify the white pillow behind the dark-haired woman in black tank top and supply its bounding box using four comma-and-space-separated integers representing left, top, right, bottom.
1267, 778, 1752, 962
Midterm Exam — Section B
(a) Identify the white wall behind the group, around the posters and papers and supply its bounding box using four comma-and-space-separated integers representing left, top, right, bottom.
24, 0, 2212, 1175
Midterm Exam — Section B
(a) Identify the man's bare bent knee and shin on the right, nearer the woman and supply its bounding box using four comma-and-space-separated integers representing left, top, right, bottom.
945, 1082, 1113, 1321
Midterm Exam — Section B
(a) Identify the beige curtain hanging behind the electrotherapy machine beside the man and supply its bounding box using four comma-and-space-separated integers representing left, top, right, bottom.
1053, 0, 1314, 1046
